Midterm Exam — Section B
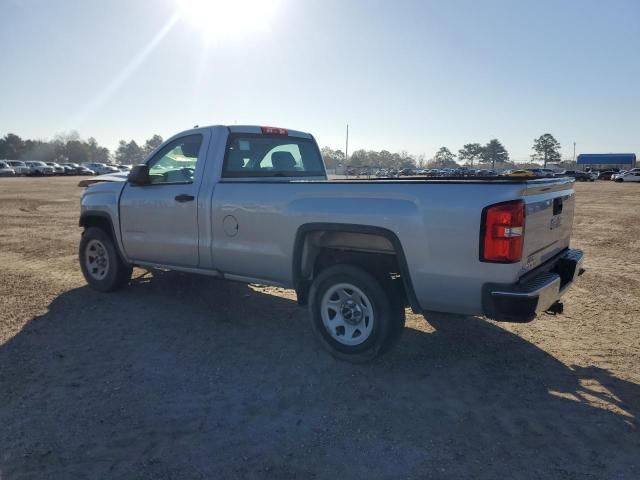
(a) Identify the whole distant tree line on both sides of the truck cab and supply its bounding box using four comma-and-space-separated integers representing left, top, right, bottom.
0, 131, 561, 169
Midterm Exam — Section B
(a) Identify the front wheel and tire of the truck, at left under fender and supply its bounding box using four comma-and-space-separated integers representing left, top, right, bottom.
79, 227, 133, 292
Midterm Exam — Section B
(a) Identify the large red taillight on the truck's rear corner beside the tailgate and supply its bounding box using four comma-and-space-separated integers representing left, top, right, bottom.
480, 200, 524, 263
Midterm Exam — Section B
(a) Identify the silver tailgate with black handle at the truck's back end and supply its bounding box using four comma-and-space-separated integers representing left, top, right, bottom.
522, 179, 575, 271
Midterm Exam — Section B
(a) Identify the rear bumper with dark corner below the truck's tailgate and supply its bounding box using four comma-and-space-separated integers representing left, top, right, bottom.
482, 249, 584, 322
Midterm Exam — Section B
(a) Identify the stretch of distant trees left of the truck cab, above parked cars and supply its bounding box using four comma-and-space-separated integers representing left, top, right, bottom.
0, 132, 162, 165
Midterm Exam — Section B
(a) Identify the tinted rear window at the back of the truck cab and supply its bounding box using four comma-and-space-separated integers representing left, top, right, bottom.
222, 133, 324, 178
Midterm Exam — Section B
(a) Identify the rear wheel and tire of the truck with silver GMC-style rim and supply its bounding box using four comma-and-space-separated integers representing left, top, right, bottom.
309, 264, 404, 363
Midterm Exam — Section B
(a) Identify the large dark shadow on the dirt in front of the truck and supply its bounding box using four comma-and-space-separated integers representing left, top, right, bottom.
0, 273, 640, 478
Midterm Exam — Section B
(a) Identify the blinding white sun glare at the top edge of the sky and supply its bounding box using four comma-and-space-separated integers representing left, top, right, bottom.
176, 0, 279, 42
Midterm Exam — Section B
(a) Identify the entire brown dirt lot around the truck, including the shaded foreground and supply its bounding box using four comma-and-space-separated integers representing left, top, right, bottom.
0, 178, 640, 480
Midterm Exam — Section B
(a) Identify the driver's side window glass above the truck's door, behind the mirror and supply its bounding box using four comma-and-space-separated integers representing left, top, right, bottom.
147, 135, 202, 185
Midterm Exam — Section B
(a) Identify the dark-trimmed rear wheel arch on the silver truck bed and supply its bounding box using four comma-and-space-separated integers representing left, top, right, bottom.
292, 223, 421, 312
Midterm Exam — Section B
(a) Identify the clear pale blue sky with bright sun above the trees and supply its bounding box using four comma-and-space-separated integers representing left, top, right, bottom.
0, 0, 640, 161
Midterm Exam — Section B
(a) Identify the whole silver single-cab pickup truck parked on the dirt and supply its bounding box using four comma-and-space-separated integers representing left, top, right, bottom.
80, 126, 583, 361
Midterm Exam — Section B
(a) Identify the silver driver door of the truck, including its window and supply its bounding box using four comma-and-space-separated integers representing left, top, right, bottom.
120, 132, 209, 267
